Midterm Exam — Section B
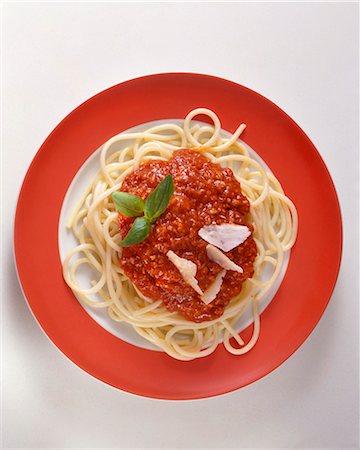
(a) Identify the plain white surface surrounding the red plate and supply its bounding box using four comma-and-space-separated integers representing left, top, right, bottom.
2, 3, 359, 449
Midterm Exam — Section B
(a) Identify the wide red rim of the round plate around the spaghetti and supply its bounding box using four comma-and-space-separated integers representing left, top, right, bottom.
14, 73, 342, 400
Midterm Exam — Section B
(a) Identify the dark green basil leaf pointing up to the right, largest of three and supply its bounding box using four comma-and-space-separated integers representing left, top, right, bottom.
144, 175, 174, 223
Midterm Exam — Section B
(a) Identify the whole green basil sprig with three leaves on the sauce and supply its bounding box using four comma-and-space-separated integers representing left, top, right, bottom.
112, 175, 174, 247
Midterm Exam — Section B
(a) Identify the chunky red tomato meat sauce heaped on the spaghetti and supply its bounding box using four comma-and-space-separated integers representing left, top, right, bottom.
119, 149, 257, 322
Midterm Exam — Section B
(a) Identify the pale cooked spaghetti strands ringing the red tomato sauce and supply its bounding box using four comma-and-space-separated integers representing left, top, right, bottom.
63, 108, 297, 361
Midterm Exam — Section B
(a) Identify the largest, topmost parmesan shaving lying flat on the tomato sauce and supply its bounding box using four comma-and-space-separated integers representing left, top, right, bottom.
199, 223, 251, 252
